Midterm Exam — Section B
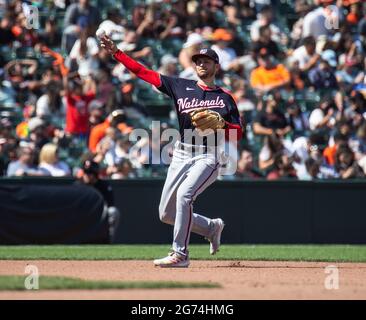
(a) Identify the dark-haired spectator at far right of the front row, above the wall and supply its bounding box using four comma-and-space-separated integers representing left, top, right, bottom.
335, 145, 365, 179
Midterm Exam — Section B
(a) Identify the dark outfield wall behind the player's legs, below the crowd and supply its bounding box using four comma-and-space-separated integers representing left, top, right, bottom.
0, 179, 366, 244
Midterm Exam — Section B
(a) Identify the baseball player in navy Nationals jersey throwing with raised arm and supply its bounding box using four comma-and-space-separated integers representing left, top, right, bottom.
99, 35, 242, 267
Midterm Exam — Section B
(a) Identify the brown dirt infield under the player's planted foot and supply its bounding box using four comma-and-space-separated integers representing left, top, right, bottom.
0, 260, 366, 299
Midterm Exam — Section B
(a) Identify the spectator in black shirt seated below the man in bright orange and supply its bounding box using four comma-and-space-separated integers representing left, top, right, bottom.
253, 97, 291, 137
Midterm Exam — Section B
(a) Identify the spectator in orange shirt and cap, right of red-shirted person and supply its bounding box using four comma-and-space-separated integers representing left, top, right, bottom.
89, 109, 133, 153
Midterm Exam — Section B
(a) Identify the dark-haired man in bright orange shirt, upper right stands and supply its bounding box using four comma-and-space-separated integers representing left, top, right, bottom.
250, 48, 290, 94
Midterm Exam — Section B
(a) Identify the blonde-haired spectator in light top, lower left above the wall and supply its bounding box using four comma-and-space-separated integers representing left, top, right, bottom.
38, 143, 71, 177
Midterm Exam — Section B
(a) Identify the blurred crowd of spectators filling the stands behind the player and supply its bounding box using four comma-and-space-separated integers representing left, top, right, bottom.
0, 0, 366, 180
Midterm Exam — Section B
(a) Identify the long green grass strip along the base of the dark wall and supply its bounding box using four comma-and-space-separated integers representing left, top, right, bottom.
0, 244, 366, 262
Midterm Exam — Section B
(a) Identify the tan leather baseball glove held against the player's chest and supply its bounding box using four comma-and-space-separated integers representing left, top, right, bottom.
190, 108, 225, 131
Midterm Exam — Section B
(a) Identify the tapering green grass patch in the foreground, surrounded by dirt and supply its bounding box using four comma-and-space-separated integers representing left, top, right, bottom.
0, 276, 220, 291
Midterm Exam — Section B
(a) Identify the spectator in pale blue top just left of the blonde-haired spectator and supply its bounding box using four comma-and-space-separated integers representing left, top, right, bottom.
6, 146, 42, 177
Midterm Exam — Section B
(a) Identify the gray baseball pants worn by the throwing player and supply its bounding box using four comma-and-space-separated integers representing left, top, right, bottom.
159, 141, 220, 255
